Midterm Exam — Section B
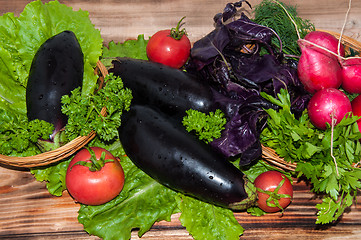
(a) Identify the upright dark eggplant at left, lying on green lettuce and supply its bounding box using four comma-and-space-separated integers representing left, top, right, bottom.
26, 31, 84, 137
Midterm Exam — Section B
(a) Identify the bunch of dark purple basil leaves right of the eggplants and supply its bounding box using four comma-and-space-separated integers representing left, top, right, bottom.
186, 1, 310, 165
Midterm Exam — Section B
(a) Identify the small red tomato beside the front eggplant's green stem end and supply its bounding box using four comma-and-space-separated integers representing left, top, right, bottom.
254, 171, 293, 213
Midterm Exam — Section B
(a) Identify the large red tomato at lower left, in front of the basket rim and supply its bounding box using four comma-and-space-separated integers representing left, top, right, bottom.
65, 147, 124, 205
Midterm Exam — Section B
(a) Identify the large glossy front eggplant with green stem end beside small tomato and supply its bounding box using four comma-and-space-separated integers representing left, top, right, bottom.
118, 105, 256, 210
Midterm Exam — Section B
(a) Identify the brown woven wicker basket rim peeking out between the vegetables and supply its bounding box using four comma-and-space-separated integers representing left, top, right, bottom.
0, 30, 361, 171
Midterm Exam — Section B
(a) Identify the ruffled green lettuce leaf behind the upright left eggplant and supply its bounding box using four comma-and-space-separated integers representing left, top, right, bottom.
0, 0, 103, 114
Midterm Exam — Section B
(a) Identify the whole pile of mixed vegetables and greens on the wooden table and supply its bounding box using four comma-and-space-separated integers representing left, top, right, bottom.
0, 0, 361, 239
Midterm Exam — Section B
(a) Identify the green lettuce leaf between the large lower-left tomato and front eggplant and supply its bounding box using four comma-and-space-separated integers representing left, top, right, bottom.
78, 157, 179, 240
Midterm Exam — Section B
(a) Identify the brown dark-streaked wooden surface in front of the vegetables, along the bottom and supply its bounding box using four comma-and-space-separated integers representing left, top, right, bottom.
0, 164, 361, 240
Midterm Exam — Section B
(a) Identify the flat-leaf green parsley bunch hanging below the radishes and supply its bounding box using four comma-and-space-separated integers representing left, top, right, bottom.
261, 89, 361, 224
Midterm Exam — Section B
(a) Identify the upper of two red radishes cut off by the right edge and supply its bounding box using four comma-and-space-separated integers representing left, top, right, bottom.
342, 58, 361, 94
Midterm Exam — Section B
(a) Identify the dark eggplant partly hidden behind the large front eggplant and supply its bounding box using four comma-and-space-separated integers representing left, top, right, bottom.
109, 57, 216, 117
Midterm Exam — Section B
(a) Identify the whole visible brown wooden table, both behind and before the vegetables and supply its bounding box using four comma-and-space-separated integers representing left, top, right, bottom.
0, 0, 361, 240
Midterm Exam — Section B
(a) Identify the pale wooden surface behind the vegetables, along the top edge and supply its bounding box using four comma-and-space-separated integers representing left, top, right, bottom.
0, 0, 361, 43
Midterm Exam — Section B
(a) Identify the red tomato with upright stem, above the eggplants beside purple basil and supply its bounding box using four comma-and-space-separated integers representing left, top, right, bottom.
146, 18, 191, 68
